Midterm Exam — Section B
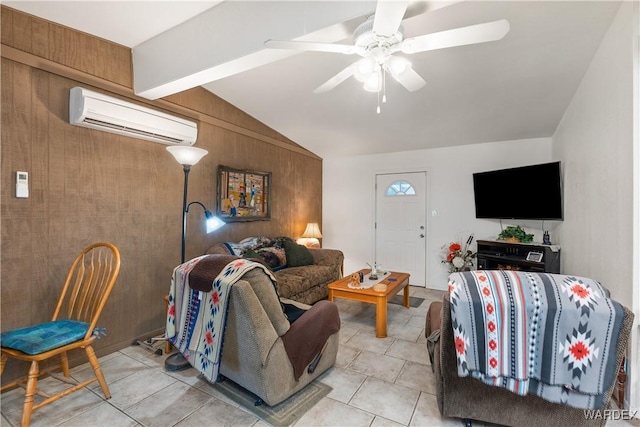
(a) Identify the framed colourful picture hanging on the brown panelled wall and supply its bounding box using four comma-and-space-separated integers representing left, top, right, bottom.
217, 166, 271, 222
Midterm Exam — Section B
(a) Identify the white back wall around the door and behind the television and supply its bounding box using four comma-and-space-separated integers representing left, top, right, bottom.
322, 138, 562, 289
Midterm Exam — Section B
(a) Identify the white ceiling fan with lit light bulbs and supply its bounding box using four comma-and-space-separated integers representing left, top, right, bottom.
264, 0, 510, 100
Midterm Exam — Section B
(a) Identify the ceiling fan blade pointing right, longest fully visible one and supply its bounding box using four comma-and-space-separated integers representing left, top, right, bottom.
401, 19, 510, 53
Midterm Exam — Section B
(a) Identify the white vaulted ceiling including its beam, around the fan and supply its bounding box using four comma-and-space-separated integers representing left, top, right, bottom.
3, 0, 620, 157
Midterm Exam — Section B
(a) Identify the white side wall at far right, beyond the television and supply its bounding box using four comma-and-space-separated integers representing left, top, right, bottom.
553, 2, 640, 408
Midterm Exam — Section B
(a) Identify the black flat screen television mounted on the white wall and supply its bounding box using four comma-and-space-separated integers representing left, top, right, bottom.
473, 162, 563, 221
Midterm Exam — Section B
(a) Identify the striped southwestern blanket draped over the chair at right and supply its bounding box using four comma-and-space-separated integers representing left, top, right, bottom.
449, 270, 624, 409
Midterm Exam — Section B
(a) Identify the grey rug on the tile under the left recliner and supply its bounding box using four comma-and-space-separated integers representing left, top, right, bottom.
212, 379, 333, 427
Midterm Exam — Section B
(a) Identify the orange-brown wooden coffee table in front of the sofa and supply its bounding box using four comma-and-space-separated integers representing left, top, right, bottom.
328, 269, 409, 338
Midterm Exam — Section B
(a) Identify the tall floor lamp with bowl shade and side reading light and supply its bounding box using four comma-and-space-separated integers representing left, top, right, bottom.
164, 145, 224, 371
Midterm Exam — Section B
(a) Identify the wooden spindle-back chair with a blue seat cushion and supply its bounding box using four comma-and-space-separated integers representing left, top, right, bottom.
0, 243, 120, 427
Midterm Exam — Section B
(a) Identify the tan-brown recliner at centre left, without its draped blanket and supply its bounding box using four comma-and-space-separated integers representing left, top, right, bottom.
220, 269, 340, 406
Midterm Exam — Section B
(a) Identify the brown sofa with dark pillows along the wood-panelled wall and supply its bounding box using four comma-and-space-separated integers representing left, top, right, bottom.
207, 236, 344, 305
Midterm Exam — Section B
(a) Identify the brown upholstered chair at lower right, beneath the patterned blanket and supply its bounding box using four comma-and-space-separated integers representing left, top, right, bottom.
425, 272, 634, 427
